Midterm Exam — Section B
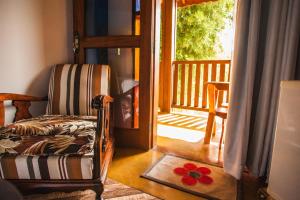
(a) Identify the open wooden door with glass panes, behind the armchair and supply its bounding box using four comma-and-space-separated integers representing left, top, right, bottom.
73, 0, 160, 149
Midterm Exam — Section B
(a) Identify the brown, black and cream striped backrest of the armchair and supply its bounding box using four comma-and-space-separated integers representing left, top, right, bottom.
46, 64, 110, 116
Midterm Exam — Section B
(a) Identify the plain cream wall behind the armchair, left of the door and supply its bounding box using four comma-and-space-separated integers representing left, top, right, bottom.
0, 0, 72, 123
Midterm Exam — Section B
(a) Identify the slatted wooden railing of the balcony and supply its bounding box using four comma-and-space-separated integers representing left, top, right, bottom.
172, 60, 230, 111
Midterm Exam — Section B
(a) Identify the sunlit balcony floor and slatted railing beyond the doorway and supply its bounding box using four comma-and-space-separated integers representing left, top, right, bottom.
158, 60, 231, 161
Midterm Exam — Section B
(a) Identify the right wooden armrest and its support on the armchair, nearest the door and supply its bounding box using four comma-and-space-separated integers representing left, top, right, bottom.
92, 95, 113, 179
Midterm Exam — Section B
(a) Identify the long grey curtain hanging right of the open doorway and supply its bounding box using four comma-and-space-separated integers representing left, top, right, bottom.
224, 0, 300, 179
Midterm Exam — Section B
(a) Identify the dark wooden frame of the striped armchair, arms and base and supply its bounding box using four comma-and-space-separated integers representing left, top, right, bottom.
0, 93, 114, 199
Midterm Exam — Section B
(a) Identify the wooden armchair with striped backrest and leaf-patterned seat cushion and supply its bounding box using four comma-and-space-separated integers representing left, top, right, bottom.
0, 64, 113, 198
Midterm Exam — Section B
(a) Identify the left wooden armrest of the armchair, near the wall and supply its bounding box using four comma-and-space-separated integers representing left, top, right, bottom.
0, 93, 47, 126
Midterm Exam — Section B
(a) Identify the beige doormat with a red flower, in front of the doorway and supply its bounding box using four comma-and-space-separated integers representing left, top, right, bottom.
142, 155, 237, 200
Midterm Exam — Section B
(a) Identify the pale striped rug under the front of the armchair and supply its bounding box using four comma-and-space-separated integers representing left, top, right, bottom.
24, 179, 159, 200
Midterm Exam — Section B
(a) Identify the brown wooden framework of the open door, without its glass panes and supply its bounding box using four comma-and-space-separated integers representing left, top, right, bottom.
73, 0, 160, 150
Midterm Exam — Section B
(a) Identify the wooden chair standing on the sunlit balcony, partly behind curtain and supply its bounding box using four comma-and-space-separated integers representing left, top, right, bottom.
204, 81, 229, 149
